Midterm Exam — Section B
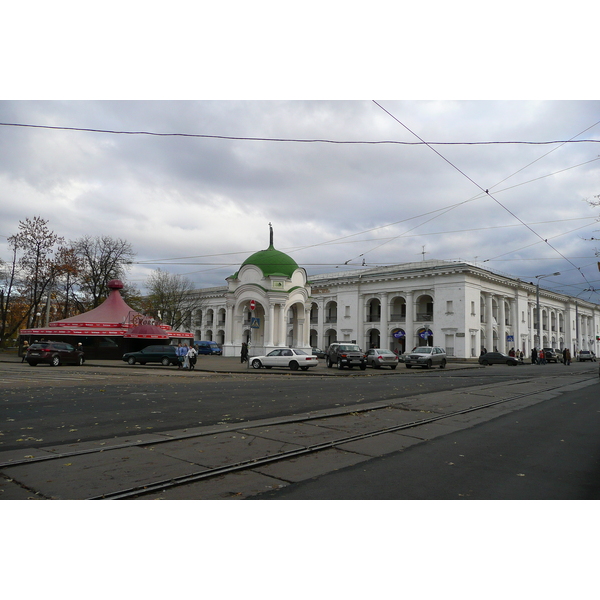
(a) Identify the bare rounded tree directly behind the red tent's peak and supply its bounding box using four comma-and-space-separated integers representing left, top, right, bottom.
72, 235, 135, 308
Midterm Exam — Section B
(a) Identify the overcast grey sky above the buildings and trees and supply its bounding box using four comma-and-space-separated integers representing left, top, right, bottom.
0, 100, 600, 301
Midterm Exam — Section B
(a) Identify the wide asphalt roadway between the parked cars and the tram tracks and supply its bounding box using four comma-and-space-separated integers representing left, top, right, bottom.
0, 363, 597, 451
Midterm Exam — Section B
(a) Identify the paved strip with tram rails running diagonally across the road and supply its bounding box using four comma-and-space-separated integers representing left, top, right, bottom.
0, 373, 598, 500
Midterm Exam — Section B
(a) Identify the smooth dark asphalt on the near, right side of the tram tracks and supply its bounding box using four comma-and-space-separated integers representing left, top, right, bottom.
254, 384, 600, 500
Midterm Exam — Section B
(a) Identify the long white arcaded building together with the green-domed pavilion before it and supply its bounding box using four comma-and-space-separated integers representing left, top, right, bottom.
182, 247, 600, 358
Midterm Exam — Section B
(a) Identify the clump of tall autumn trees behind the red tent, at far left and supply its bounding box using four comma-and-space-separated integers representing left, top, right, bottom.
0, 217, 139, 345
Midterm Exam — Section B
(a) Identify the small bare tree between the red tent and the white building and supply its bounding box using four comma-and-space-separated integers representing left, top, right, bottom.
146, 269, 194, 330
